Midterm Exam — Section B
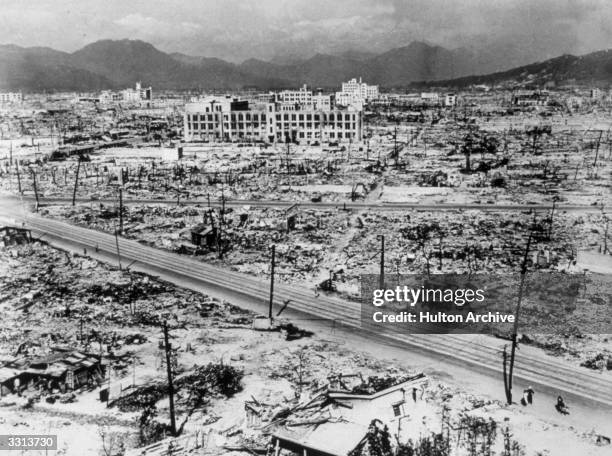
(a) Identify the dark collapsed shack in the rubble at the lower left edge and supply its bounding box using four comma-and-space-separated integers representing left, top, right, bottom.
0, 349, 105, 397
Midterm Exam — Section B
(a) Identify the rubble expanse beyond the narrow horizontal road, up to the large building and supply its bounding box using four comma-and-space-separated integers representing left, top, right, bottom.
0, 111, 612, 205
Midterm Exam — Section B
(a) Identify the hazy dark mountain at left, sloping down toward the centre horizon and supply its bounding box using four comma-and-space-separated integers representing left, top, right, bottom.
0, 40, 288, 91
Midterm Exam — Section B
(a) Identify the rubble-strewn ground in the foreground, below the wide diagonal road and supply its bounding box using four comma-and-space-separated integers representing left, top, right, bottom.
0, 242, 604, 455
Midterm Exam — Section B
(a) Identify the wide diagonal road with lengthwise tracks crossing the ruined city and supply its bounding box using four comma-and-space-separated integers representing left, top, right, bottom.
2, 206, 612, 407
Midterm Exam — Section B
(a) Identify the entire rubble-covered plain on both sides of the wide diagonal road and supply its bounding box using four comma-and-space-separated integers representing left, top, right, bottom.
0, 89, 612, 456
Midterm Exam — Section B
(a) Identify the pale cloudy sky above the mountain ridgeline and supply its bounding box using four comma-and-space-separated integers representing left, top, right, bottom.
0, 0, 612, 63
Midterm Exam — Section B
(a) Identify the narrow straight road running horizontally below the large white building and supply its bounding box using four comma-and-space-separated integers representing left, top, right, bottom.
15, 196, 609, 212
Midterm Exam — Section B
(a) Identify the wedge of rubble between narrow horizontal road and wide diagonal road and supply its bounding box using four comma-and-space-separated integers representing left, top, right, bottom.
40, 203, 607, 282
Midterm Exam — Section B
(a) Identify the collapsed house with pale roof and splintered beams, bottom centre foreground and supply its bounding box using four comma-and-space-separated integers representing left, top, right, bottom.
245, 374, 432, 456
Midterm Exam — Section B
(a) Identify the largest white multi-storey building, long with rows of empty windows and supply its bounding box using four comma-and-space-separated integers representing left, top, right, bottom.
184, 97, 363, 144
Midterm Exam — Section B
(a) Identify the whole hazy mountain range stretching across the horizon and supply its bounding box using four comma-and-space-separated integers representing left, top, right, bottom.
0, 40, 612, 91
